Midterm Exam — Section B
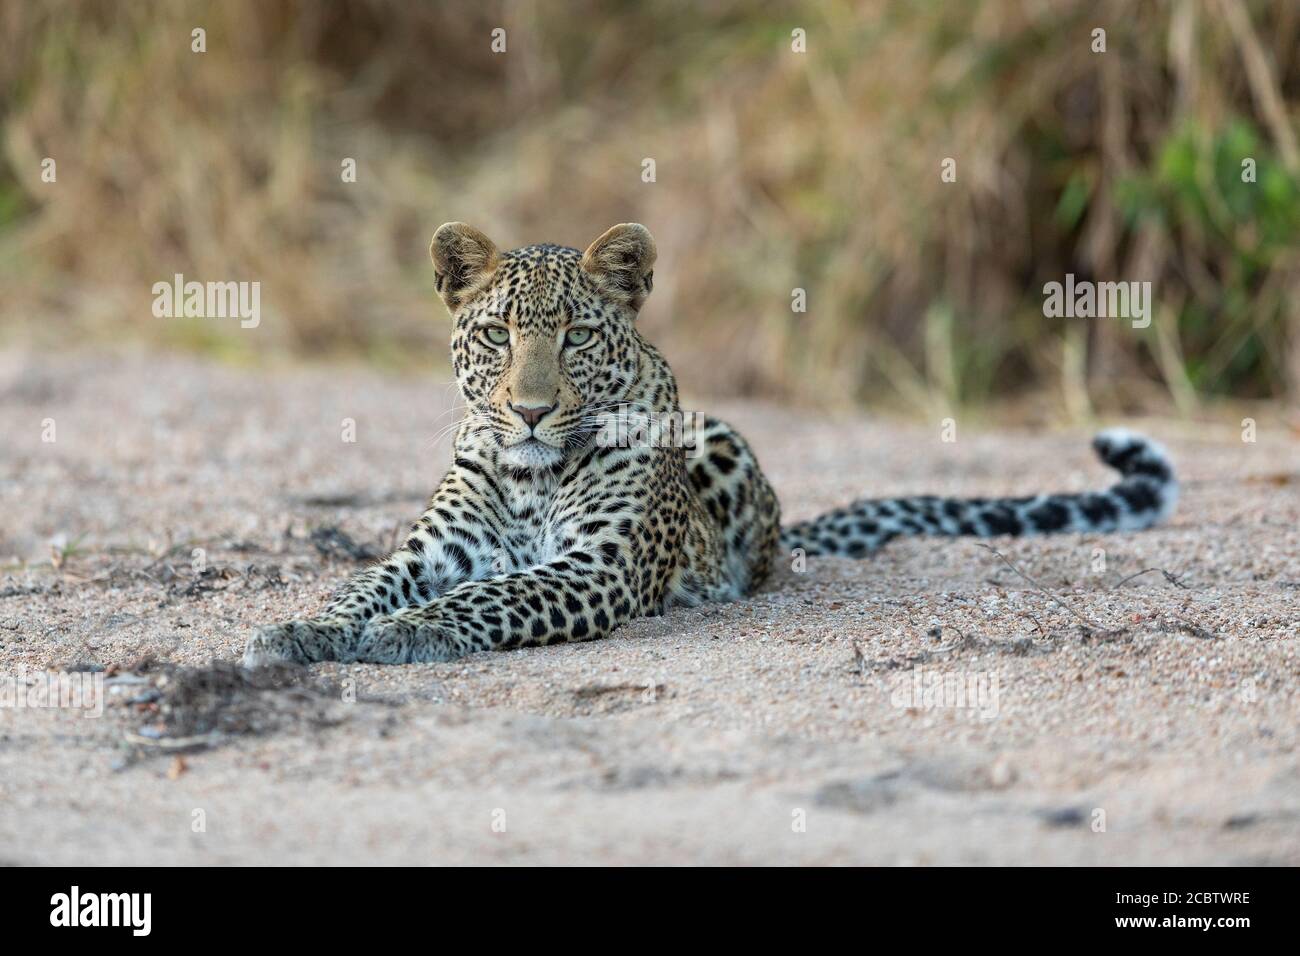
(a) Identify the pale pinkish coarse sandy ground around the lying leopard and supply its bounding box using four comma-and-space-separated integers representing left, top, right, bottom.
0, 352, 1300, 865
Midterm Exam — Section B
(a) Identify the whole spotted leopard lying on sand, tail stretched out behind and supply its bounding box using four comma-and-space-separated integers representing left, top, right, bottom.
243, 222, 1178, 667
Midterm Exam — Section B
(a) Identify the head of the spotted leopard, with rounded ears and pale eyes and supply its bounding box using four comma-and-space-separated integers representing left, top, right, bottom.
429, 222, 655, 468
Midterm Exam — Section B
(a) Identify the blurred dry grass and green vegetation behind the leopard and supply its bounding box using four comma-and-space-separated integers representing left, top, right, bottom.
0, 0, 1300, 418
